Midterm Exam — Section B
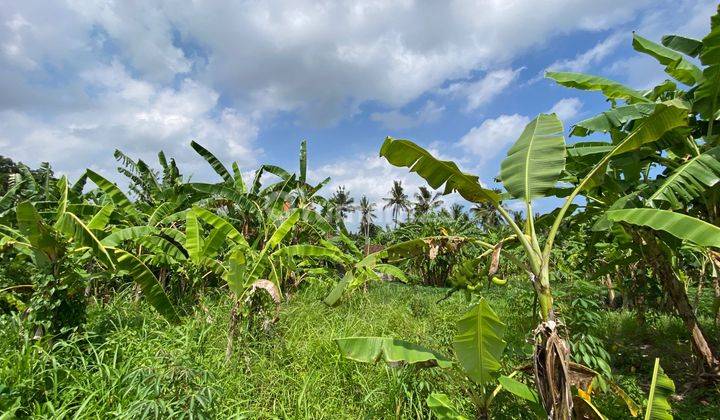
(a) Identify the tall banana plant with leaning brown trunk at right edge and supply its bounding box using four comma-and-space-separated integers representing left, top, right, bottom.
548, 9, 720, 376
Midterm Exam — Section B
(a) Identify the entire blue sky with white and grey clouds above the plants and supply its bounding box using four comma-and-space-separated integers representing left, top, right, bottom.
0, 0, 717, 228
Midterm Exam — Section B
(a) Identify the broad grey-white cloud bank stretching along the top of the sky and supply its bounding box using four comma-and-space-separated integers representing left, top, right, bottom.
0, 0, 649, 123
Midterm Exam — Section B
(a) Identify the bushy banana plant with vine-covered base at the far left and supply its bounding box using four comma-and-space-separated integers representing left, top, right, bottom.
0, 177, 179, 336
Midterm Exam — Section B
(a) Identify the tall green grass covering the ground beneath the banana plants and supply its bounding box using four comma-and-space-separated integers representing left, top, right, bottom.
0, 284, 720, 419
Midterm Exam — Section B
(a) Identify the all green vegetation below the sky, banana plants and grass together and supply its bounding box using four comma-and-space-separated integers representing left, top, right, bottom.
0, 7, 720, 419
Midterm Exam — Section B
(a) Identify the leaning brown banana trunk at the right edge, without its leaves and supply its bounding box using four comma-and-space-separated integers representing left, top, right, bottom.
646, 235, 720, 375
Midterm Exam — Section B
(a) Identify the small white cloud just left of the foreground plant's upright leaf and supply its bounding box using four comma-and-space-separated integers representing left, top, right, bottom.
459, 114, 530, 163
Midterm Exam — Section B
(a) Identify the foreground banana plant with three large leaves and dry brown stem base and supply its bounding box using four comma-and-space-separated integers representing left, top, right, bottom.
380, 92, 688, 418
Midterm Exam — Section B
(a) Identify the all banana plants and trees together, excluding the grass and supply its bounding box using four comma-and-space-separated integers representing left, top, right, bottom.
0, 4, 720, 419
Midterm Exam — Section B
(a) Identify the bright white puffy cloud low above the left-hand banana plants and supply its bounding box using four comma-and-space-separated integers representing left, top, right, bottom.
0, 62, 258, 180
